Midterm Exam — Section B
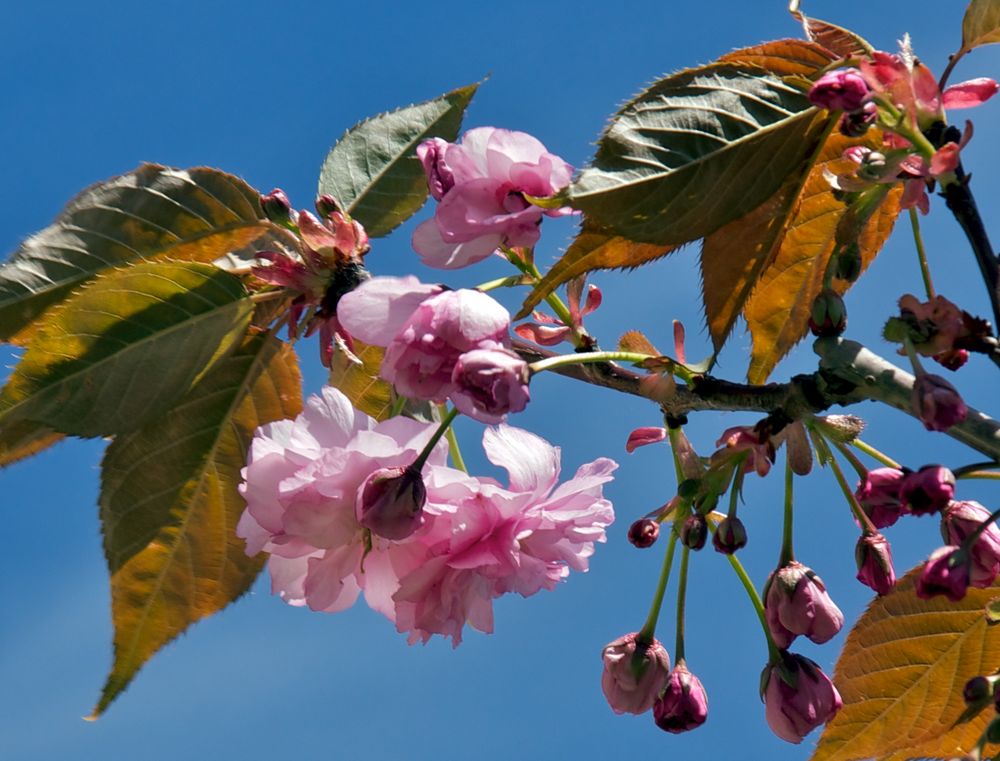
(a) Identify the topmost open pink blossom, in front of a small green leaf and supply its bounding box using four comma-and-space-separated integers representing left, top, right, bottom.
412, 127, 573, 269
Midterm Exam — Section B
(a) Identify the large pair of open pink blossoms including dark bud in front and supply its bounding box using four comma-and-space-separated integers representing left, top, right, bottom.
237, 388, 617, 645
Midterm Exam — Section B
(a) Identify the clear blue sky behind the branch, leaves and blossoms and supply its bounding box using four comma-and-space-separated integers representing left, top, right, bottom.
0, 0, 1000, 761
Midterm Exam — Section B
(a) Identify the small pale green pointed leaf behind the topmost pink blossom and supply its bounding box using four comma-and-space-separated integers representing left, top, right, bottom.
319, 84, 479, 238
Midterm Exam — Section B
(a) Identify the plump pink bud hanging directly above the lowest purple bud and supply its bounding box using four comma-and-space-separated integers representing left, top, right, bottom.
764, 560, 844, 648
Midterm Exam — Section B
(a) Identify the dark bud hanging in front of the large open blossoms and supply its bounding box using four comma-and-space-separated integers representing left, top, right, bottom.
355, 467, 427, 540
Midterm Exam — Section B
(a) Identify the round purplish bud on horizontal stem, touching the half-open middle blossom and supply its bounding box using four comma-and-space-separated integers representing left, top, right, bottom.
451, 349, 531, 423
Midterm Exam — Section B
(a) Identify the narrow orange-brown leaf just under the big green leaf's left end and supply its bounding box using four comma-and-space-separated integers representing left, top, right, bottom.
514, 220, 677, 320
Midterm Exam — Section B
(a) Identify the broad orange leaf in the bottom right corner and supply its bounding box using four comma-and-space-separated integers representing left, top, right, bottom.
812, 567, 1000, 761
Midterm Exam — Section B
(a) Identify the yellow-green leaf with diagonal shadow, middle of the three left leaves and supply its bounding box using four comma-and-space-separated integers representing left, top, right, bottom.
0, 262, 253, 440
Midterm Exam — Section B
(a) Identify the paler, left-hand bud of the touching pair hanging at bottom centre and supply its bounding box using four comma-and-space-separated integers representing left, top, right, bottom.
601, 632, 670, 714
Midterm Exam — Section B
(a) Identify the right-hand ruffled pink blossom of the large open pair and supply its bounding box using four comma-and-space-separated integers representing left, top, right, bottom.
392, 425, 618, 646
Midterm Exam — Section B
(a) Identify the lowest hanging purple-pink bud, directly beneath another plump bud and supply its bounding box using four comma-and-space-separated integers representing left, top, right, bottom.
762, 653, 843, 744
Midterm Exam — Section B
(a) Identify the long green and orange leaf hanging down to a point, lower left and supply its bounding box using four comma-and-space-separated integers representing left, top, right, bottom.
91, 335, 302, 718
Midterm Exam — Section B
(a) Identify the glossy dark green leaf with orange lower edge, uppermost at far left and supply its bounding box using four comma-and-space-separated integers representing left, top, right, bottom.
0, 164, 294, 344
